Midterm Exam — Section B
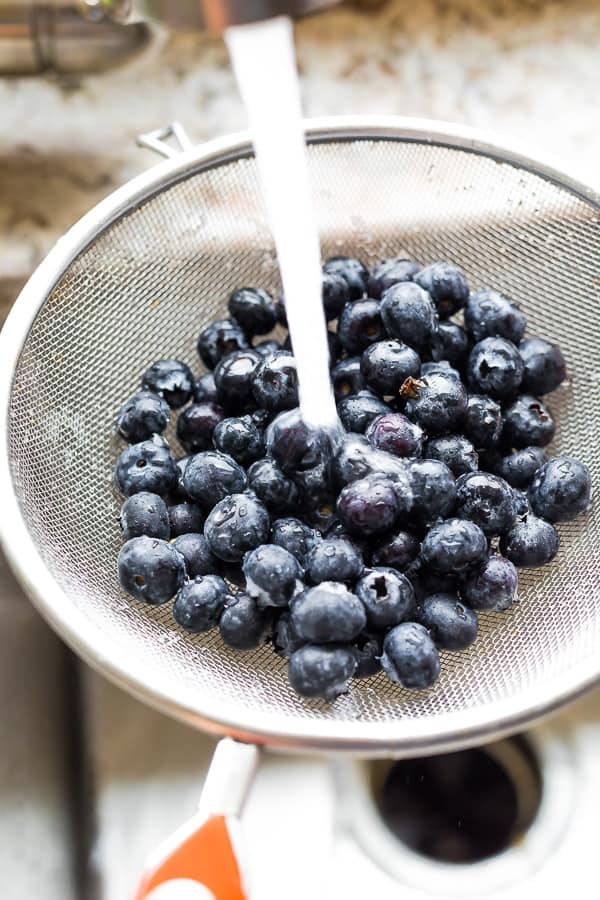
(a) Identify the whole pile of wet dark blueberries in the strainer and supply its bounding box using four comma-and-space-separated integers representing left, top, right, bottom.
116, 257, 591, 699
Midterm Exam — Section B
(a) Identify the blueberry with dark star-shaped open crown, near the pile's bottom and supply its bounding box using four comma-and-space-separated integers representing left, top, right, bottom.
355, 567, 416, 631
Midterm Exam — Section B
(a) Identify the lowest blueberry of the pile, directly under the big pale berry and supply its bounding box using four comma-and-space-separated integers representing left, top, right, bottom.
288, 644, 357, 700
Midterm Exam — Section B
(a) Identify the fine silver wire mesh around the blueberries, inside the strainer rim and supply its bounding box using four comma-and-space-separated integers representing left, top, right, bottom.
9, 139, 600, 736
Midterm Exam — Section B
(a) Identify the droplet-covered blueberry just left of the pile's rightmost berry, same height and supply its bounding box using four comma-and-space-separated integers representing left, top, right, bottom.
456, 472, 517, 537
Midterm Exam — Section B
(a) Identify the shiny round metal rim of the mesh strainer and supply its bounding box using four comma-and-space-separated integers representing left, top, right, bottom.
0, 116, 600, 755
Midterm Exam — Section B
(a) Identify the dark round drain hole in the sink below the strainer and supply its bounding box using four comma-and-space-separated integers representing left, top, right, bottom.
374, 738, 541, 863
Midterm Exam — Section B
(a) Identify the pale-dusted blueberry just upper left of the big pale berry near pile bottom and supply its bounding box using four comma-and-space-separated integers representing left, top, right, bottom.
242, 544, 302, 606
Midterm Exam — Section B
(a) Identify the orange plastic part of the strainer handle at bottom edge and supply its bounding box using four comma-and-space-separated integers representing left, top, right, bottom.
136, 816, 248, 900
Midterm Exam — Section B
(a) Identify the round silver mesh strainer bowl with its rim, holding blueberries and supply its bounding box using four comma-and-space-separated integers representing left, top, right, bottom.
0, 120, 600, 753
